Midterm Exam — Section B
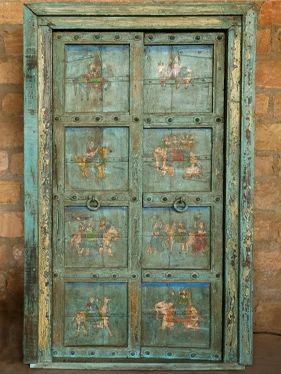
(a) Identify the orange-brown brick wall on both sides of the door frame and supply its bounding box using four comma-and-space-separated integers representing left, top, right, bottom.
0, 0, 281, 340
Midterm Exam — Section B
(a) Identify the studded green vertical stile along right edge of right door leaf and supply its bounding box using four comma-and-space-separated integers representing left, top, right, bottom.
211, 33, 225, 357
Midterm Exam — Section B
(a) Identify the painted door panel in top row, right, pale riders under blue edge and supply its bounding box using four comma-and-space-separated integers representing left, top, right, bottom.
144, 44, 213, 114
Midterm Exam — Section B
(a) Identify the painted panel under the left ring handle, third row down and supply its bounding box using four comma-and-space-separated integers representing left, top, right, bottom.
64, 207, 128, 268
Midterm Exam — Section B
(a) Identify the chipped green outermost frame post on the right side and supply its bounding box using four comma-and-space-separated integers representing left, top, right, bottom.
239, 9, 256, 365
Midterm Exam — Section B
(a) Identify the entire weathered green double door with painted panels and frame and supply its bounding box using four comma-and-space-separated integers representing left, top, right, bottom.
25, 2, 254, 370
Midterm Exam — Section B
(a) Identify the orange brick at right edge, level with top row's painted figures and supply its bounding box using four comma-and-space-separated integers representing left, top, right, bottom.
256, 59, 281, 88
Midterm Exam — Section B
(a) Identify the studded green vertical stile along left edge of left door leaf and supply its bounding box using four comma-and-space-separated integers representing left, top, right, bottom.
52, 34, 65, 355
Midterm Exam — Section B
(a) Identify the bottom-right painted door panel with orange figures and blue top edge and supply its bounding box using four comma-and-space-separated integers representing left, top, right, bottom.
142, 282, 211, 348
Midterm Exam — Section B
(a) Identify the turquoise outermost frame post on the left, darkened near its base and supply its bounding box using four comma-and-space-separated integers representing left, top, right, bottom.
23, 7, 38, 363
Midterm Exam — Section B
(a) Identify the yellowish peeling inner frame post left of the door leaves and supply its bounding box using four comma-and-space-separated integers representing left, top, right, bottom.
38, 26, 52, 362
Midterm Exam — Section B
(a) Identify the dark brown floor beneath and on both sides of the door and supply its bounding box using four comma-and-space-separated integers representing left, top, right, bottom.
0, 313, 281, 374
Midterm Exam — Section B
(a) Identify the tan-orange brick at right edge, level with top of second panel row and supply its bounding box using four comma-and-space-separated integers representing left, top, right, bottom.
256, 124, 281, 152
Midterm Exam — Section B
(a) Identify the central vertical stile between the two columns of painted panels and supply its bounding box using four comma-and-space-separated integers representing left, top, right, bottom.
128, 32, 143, 357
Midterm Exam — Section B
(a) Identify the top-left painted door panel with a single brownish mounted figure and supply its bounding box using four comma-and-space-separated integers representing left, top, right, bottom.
65, 44, 129, 112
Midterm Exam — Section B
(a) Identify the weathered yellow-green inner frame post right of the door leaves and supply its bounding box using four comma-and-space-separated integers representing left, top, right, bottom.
224, 27, 241, 362
